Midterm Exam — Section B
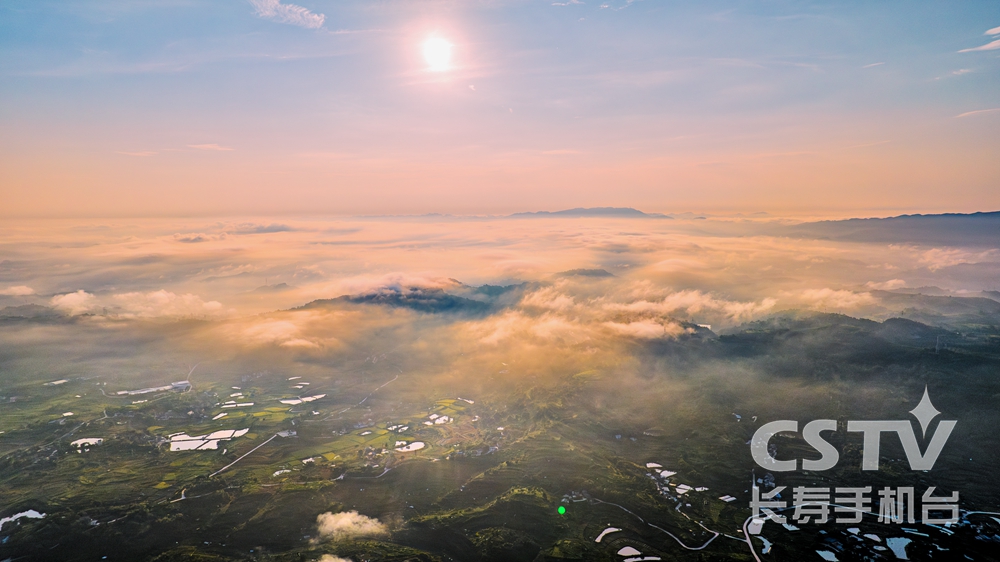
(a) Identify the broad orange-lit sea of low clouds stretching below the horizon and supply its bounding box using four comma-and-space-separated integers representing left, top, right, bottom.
17, 215, 1000, 344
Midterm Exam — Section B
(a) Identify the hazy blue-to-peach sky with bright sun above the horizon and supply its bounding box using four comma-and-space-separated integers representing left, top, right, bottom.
0, 0, 1000, 218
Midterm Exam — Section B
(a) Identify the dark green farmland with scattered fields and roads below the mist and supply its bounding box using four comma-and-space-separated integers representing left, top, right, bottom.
0, 306, 1000, 561
